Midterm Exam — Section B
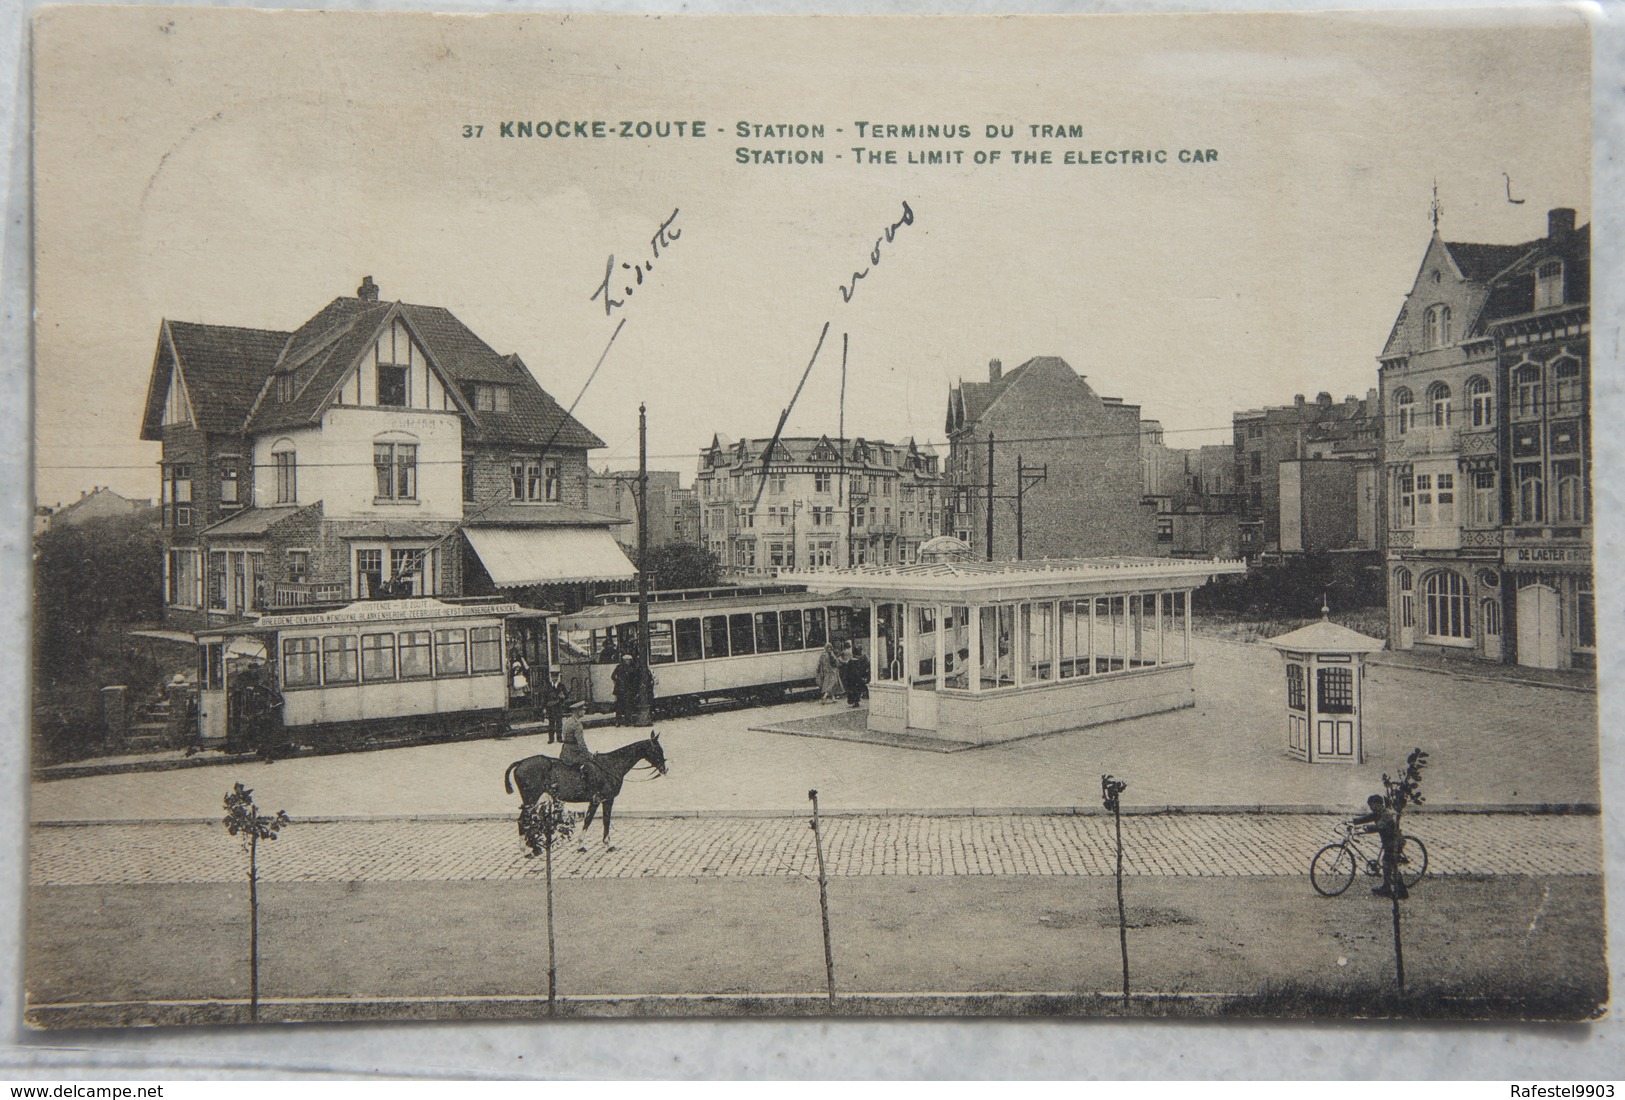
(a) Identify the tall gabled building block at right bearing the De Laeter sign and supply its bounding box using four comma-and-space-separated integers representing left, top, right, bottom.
1380, 210, 1597, 668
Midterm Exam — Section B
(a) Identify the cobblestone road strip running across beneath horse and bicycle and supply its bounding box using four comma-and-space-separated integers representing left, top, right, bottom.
29, 814, 1602, 886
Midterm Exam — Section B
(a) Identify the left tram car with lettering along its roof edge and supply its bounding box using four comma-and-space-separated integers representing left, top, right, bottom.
197, 598, 557, 751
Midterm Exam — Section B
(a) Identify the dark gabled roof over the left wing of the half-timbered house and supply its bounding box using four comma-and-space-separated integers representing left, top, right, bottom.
141, 320, 288, 440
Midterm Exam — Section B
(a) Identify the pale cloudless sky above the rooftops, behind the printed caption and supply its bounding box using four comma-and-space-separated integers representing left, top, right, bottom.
34, 8, 1591, 504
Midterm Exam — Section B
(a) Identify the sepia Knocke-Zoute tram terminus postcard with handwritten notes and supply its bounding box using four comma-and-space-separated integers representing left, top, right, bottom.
23, 6, 1609, 1029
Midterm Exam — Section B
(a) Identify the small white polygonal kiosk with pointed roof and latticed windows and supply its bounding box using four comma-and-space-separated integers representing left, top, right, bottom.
1269, 617, 1383, 764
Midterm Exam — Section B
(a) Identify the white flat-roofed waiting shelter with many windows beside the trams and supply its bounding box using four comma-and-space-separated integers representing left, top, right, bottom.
798, 557, 1246, 744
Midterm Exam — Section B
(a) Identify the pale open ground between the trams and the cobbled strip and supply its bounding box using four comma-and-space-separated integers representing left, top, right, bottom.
29, 637, 1601, 821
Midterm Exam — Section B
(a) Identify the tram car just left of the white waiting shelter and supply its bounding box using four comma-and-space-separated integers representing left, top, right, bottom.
557, 585, 869, 713
